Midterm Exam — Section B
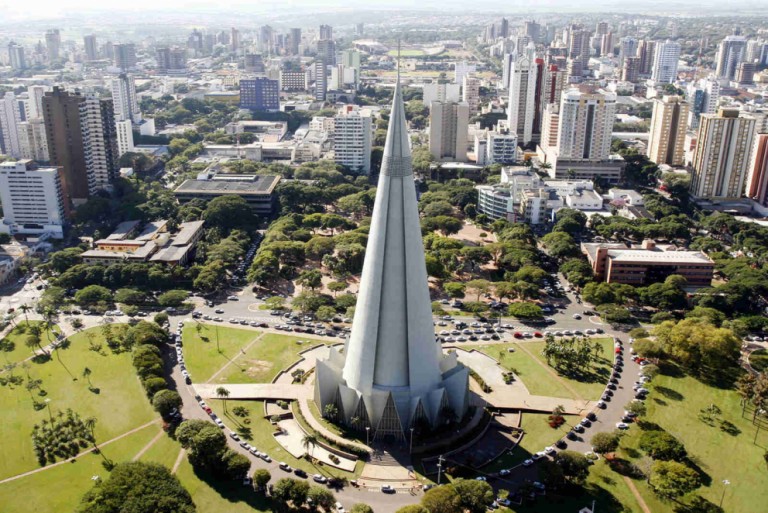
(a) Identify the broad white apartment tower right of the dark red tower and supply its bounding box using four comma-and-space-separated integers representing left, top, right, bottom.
557, 89, 616, 161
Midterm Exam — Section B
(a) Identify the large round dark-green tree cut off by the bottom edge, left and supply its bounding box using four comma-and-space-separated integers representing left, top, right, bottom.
77, 461, 196, 513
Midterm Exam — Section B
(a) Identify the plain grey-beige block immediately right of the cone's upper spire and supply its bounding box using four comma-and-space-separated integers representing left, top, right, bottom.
429, 102, 469, 162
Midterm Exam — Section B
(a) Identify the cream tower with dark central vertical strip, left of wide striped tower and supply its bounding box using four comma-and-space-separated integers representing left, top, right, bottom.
648, 96, 690, 167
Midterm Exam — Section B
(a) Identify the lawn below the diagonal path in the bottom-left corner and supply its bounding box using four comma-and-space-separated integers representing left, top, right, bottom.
0, 425, 160, 513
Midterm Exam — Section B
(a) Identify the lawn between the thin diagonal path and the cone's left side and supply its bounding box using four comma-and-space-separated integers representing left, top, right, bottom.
213, 333, 332, 383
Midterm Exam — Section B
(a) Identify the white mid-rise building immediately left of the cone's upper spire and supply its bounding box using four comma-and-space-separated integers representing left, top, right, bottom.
333, 105, 373, 175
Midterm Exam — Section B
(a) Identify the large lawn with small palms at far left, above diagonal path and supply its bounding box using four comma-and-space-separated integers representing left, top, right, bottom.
0, 328, 155, 479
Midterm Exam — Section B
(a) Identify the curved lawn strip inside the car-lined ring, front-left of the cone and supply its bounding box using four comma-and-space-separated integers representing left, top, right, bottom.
208, 400, 362, 479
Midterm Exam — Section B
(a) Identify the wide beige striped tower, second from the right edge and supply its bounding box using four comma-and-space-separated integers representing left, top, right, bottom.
691, 109, 756, 200
